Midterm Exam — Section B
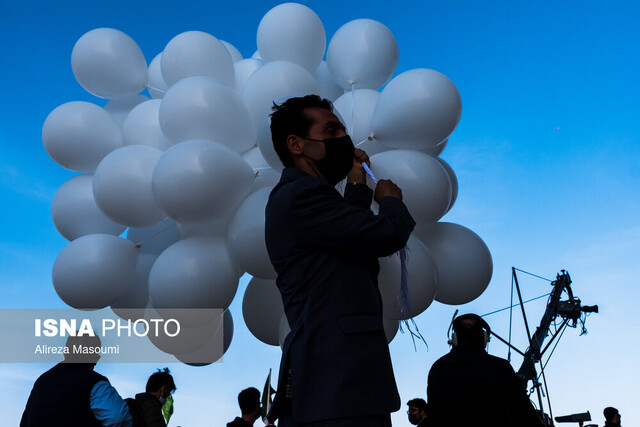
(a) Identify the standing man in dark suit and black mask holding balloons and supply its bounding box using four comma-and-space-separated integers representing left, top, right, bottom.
265, 95, 415, 427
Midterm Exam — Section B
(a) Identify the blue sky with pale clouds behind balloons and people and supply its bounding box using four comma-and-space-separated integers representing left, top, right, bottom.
0, 0, 640, 426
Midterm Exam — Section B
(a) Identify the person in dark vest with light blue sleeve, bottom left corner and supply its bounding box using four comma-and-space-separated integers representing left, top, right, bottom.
20, 336, 132, 427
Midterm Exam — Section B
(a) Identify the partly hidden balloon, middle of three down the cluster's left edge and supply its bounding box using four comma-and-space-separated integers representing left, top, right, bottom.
51, 174, 126, 240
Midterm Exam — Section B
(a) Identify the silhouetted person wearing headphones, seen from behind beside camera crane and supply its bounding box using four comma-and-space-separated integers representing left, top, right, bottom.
427, 314, 542, 427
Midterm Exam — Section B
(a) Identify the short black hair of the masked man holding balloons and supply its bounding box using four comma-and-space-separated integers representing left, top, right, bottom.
271, 95, 333, 167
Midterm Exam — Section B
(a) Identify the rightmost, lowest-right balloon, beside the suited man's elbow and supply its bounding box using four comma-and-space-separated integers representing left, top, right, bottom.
414, 222, 493, 305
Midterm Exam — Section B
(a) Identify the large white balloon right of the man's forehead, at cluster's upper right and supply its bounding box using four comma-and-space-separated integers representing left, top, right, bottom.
373, 69, 462, 150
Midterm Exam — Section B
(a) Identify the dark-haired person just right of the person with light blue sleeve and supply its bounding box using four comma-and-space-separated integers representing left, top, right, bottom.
132, 368, 176, 427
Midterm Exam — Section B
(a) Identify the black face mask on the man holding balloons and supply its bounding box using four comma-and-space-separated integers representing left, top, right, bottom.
304, 135, 356, 185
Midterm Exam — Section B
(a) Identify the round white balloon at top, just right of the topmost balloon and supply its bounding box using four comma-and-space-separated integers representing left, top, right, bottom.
327, 19, 398, 89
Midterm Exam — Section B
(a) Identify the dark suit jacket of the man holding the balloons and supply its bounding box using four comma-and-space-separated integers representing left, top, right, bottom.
265, 168, 415, 423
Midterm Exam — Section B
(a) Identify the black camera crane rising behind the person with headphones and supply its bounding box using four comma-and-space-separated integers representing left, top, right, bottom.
491, 267, 598, 424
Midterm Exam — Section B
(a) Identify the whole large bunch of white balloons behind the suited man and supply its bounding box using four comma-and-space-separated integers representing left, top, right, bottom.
42, 3, 492, 362
